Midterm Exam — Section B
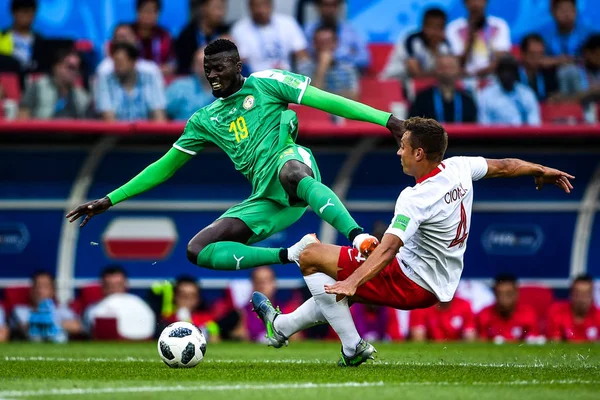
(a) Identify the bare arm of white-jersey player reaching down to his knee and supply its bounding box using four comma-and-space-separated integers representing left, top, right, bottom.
325, 233, 404, 296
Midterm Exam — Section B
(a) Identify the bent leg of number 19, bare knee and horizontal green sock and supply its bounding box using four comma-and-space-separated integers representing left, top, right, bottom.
187, 218, 289, 271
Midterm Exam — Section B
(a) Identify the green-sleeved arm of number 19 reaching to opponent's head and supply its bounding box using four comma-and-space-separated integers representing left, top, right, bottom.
300, 86, 404, 137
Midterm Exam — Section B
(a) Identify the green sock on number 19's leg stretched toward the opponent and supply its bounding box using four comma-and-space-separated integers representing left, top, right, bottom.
297, 176, 363, 237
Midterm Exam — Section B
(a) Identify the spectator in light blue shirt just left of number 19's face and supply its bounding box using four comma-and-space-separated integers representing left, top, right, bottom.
166, 48, 215, 121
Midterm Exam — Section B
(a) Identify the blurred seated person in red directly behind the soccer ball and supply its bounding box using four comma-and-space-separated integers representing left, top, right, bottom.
165, 276, 219, 342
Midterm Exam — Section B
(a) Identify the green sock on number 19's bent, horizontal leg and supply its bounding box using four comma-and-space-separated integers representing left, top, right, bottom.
197, 242, 282, 271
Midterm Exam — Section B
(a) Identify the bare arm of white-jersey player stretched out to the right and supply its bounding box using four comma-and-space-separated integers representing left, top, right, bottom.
485, 158, 575, 193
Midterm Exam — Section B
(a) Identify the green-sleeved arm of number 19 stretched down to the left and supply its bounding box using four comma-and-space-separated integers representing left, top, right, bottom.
66, 148, 192, 227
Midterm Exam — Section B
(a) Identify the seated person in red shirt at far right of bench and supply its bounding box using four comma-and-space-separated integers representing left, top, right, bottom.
547, 275, 600, 342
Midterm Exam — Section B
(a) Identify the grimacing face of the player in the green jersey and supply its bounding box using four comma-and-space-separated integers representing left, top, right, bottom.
204, 53, 242, 97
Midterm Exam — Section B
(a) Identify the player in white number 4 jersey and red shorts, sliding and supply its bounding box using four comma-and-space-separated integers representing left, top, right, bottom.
252, 117, 574, 366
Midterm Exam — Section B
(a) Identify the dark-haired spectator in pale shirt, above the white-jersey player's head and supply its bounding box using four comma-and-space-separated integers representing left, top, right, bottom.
382, 8, 452, 79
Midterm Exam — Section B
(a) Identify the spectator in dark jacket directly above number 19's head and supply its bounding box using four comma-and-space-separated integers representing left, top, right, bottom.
175, 0, 231, 75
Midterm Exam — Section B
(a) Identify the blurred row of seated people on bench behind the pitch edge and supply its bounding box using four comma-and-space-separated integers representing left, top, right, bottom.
0, 266, 600, 344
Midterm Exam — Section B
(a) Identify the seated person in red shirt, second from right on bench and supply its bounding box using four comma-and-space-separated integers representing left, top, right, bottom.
477, 274, 538, 343
